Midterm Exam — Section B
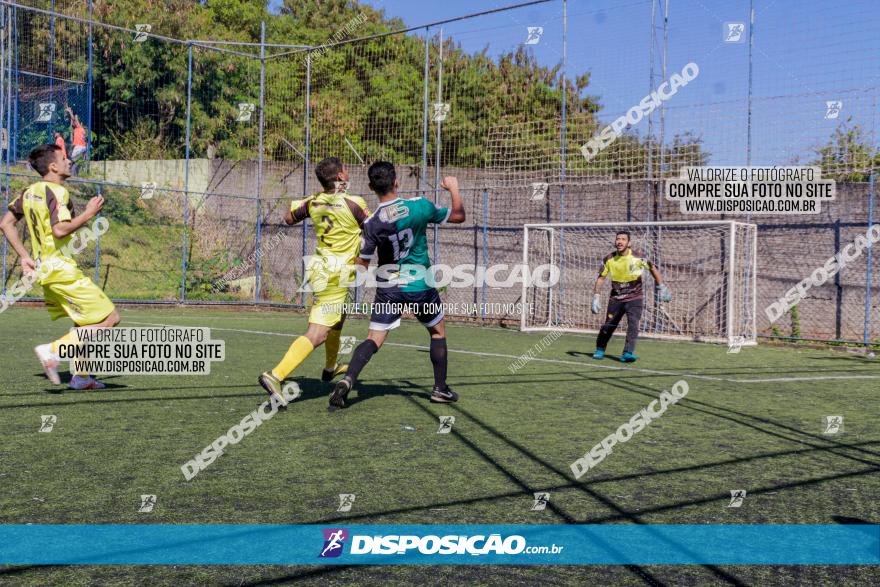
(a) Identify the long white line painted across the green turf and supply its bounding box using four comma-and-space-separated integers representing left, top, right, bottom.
125, 320, 880, 383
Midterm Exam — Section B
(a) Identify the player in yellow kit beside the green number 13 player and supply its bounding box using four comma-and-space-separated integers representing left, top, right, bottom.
259, 157, 370, 404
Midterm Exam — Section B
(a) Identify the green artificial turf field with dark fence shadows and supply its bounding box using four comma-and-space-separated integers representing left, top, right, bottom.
0, 306, 880, 585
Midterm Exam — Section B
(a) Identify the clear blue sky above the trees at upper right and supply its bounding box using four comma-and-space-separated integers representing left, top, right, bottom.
276, 0, 880, 165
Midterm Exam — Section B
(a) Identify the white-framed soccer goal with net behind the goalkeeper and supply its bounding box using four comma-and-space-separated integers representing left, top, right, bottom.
522, 221, 758, 345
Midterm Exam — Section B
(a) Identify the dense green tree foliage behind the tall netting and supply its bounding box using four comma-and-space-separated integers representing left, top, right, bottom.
22, 0, 696, 172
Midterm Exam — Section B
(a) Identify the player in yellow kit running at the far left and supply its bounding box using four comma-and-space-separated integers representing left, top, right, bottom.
0, 145, 119, 389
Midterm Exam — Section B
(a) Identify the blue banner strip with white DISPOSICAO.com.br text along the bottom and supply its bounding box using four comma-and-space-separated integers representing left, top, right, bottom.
0, 524, 880, 565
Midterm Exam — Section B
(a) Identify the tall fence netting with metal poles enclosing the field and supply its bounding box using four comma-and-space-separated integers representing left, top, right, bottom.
0, 0, 880, 343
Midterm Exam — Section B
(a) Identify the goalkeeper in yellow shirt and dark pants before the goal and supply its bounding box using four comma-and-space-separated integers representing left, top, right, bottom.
591, 230, 672, 363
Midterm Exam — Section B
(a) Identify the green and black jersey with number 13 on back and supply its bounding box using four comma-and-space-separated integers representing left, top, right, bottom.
360, 198, 449, 292
